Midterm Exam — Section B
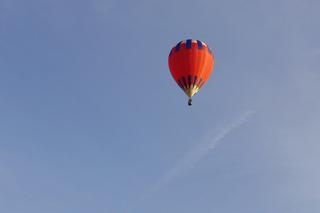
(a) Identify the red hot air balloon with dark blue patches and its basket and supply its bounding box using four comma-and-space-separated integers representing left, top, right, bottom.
168, 39, 214, 106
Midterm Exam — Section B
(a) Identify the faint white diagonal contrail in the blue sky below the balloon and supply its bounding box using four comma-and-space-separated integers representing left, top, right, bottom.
151, 111, 255, 193
